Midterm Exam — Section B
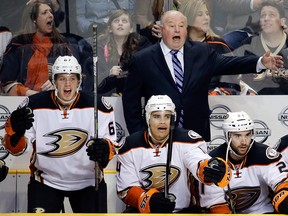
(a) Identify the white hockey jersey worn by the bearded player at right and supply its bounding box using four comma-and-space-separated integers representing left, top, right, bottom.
199, 142, 287, 214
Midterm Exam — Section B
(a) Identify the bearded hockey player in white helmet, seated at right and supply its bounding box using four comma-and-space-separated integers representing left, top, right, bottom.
200, 111, 288, 214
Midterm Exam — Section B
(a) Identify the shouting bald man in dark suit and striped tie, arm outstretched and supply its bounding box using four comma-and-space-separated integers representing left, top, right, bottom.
122, 10, 283, 141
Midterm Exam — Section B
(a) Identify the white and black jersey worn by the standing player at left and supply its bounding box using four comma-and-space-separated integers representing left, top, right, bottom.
21, 91, 116, 191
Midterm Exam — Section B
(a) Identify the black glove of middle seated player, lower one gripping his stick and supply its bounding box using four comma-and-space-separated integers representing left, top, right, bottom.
149, 192, 175, 213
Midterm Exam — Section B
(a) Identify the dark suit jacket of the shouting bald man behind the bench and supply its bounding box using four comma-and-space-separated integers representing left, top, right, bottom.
122, 42, 259, 141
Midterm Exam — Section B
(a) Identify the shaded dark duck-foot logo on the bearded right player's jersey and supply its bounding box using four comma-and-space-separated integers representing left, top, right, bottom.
226, 187, 261, 211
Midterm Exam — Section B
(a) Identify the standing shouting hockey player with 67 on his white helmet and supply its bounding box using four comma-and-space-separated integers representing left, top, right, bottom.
3, 56, 116, 213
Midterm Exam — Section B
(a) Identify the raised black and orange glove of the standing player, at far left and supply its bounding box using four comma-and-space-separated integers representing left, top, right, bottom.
3, 106, 34, 155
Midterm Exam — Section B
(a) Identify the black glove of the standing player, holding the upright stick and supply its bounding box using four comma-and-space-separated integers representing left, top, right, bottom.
86, 138, 110, 167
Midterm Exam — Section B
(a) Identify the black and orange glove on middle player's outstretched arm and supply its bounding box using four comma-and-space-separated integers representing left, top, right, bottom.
203, 158, 231, 187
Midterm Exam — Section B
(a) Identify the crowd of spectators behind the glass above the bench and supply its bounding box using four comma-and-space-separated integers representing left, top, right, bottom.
0, 0, 288, 96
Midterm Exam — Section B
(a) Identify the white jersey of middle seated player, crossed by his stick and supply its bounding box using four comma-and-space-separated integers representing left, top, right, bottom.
117, 128, 210, 212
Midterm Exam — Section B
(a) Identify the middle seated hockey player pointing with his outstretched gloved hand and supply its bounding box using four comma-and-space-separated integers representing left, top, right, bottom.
117, 95, 230, 213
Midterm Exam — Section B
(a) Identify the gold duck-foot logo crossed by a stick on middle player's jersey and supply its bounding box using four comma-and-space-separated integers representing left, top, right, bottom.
140, 164, 181, 190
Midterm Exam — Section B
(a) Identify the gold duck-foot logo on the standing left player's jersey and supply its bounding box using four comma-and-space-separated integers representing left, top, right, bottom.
39, 128, 88, 157
